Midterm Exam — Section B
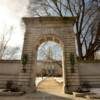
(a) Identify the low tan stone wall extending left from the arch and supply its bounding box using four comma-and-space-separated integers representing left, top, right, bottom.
0, 60, 21, 88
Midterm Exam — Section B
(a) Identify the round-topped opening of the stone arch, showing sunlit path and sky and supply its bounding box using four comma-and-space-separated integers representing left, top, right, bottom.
36, 40, 64, 92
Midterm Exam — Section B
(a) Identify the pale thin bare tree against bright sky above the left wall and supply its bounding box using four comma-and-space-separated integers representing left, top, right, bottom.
0, 27, 20, 59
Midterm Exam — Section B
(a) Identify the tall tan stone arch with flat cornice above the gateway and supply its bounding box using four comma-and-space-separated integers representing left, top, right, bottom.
19, 17, 80, 92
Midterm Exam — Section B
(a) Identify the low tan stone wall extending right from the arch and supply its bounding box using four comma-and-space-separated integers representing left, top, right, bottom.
79, 63, 100, 88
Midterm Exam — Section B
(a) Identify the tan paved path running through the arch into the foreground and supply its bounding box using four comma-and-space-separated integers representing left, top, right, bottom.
0, 78, 85, 100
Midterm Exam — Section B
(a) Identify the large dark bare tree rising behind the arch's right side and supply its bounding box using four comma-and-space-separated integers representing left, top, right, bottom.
28, 0, 100, 59
